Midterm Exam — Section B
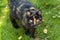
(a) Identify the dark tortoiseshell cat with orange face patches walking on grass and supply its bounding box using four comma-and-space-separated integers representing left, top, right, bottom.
8, 0, 42, 37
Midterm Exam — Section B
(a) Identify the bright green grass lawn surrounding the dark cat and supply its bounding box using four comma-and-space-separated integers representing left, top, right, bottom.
0, 0, 60, 40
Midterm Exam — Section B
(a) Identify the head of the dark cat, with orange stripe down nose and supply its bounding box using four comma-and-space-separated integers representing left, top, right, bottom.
25, 7, 42, 26
